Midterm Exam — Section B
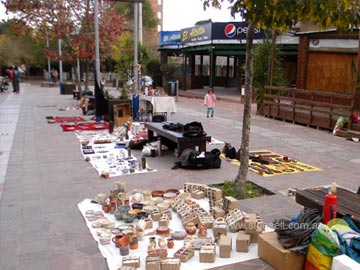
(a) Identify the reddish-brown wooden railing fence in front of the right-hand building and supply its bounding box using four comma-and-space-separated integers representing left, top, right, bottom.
258, 86, 354, 130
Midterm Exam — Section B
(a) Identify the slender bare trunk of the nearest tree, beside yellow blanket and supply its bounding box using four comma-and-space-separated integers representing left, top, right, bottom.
235, 21, 256, 195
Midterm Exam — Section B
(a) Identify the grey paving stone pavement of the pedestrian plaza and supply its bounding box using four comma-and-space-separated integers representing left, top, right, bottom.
0, 82, 360, 270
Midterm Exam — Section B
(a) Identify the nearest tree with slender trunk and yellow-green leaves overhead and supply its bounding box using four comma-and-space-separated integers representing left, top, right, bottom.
202, 0, 360, 194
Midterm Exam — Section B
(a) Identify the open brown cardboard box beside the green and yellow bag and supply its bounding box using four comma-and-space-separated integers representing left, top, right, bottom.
258, 232, 306, 270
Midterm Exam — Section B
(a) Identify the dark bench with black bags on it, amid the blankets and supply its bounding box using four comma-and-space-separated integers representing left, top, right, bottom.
144, 122, 211, 157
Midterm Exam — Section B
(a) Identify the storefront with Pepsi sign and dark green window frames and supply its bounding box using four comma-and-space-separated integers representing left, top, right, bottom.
159, 22, 298, 89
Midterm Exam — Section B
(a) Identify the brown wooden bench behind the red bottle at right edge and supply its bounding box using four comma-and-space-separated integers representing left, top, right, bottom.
295, 187, 360, 226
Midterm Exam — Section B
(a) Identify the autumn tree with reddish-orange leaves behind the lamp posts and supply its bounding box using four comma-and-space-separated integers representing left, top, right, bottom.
1, 0, 123, 90
